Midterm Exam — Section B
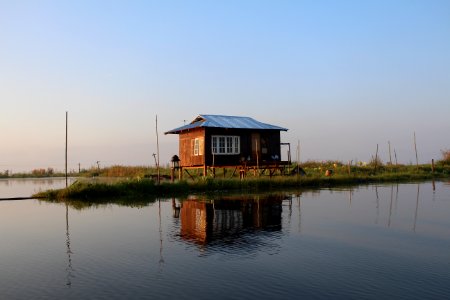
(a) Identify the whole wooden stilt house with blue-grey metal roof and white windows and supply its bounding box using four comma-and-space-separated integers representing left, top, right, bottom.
165, 115, 291, 176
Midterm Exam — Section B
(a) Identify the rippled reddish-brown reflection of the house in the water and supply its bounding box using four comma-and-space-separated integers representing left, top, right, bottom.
180, 195, 287, 244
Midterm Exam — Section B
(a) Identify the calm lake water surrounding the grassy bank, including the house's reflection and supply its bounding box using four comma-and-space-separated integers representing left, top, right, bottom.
0, 179, 450, 299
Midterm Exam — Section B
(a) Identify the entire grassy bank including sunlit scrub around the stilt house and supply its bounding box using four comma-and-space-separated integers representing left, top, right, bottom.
34, 159, 450, 202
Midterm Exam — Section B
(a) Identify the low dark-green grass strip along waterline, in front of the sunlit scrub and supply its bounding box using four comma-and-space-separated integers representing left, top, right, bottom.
34, 171, 449, 201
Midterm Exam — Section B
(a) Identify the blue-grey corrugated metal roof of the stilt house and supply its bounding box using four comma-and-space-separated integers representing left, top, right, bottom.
165, 115, 287, 134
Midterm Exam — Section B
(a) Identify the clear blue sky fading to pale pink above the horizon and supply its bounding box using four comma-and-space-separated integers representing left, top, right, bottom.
0, 0, 450, 172
